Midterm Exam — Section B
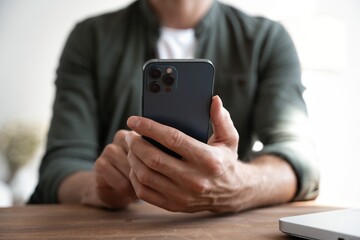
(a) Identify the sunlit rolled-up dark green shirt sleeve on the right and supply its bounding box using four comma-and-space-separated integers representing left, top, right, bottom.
253, 23, 319, 200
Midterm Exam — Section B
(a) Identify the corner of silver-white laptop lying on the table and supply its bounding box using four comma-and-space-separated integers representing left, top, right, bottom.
279, 209, 360, 240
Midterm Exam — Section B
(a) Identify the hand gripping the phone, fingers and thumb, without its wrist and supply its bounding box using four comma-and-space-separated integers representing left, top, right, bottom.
126, 97, 246, 212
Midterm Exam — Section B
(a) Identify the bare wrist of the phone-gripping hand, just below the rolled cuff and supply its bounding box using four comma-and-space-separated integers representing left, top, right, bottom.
221, 155, 296, 212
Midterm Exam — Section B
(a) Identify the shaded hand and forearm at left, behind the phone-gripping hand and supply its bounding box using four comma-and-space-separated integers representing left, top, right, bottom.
59, 130, 137, 209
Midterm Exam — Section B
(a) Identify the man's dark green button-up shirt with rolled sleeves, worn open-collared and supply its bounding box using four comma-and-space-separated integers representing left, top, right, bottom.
29, 1, 319, 203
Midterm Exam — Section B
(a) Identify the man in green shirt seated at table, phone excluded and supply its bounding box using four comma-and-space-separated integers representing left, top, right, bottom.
30, 0, 319, 212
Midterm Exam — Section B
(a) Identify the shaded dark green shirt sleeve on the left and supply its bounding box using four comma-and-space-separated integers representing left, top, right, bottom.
29, 22, 98, 203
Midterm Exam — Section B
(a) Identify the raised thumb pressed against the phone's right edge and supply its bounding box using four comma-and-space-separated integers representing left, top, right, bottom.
209, 96, 239, 149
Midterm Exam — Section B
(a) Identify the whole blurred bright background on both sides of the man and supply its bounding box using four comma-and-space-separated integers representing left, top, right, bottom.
0, 0, 360, 207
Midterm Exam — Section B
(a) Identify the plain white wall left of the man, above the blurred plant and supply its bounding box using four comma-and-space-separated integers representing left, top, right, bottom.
0, 0, 134, 126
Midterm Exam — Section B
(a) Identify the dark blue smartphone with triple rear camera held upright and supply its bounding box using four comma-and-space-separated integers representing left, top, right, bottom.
142, 59, 215, 158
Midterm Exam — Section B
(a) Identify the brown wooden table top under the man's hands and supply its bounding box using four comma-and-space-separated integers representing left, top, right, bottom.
0, 203, 333, 240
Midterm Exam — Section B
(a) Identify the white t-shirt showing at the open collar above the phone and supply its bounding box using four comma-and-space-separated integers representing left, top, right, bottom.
157, 27, 196, 59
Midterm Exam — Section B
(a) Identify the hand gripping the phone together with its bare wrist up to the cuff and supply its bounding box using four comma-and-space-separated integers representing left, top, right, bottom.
126, 97, 296, 212
